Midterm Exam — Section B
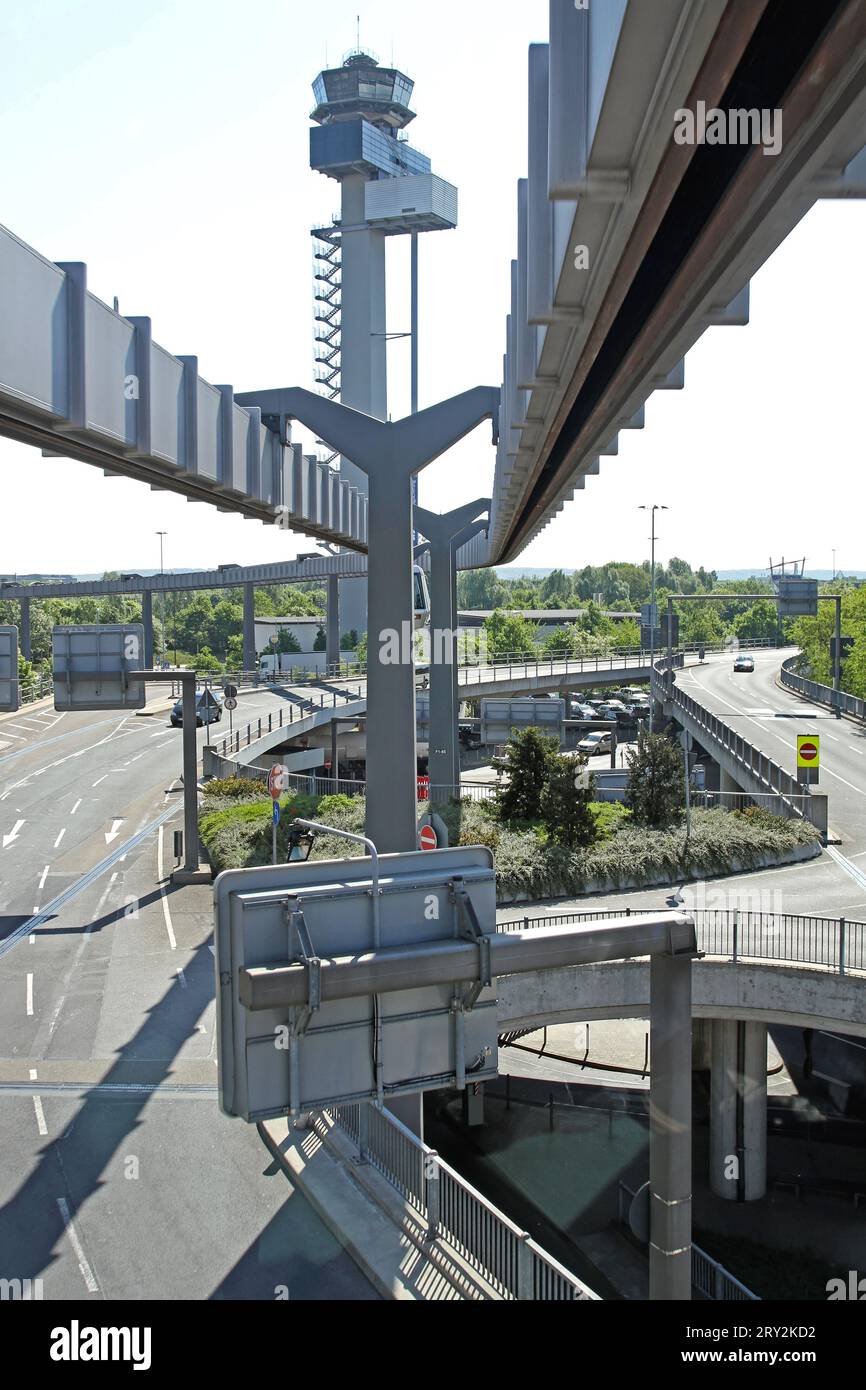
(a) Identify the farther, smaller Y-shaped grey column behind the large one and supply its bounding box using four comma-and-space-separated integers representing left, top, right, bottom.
414, 498, 491, 801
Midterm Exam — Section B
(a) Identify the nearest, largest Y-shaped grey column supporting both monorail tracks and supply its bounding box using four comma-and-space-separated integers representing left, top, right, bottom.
235, 386, 499, 853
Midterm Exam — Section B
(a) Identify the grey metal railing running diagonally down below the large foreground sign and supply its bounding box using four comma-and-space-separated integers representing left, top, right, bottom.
327, 1105, 599, 1302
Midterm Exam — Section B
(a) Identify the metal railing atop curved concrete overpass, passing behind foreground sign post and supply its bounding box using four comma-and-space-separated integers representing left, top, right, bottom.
508, 908, 866, 974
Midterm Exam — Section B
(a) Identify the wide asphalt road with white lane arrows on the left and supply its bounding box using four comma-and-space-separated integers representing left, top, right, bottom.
0, 691, 375, 1301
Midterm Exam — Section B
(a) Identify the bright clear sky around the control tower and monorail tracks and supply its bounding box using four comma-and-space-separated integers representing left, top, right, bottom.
0, 0, 866, 573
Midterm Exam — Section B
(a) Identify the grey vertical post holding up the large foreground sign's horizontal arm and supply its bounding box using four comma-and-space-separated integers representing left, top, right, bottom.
649, 955, 692, 1301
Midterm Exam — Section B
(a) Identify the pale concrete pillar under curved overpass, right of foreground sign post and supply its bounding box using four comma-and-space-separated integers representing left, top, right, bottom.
709, 1019, 767, 1202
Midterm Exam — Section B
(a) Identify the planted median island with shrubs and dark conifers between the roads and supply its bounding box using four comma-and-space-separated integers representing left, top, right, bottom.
200, 728, 822, 902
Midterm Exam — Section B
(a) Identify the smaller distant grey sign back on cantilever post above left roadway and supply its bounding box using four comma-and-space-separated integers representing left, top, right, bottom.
51, 623, 147, 710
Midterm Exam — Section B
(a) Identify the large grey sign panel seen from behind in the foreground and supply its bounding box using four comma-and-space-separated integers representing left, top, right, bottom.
214, 847, 498, 1123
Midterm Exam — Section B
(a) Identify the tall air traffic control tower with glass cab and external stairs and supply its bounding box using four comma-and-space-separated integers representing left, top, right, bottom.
310, 51, 457, 632
